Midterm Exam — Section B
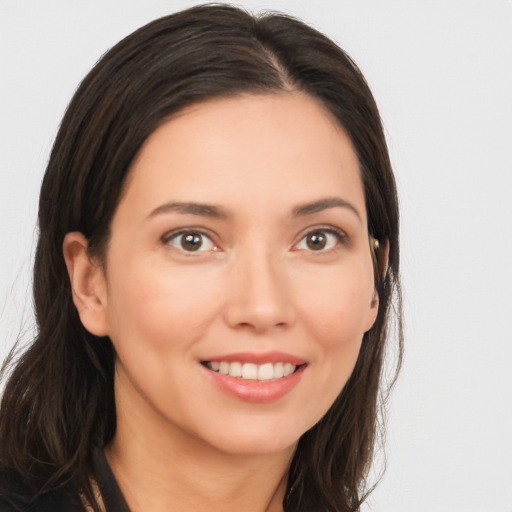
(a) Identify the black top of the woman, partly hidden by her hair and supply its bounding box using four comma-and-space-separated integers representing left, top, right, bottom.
0, 449, 130, 512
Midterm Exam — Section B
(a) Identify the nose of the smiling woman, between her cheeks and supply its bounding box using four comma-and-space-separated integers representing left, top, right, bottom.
225, 247, 295, 333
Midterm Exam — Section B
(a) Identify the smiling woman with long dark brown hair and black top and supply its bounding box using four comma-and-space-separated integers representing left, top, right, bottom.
0, 6, 401, 512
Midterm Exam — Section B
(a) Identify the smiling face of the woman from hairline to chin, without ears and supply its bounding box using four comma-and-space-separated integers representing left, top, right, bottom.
93, 93, 377, 454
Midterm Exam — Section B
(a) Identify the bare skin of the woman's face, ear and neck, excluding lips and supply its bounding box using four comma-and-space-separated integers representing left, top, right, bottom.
64, 92, 378, 512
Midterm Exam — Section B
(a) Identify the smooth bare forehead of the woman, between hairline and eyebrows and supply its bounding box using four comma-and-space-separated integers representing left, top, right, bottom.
122, 92, 364, 220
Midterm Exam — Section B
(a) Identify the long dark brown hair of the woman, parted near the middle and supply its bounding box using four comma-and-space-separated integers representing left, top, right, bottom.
0, 5, 402, 512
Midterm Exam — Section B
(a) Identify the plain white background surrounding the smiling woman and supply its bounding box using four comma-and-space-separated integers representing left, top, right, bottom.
0, 0, 512, 512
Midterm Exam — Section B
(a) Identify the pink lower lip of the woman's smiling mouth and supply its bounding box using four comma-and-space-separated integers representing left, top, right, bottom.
203, 365, 306, 404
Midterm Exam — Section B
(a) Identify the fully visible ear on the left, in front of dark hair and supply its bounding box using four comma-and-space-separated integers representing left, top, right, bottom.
62, 231, 108, 336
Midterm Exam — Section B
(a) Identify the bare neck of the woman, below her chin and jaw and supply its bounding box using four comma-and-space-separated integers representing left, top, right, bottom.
106, 378, 295, 512
